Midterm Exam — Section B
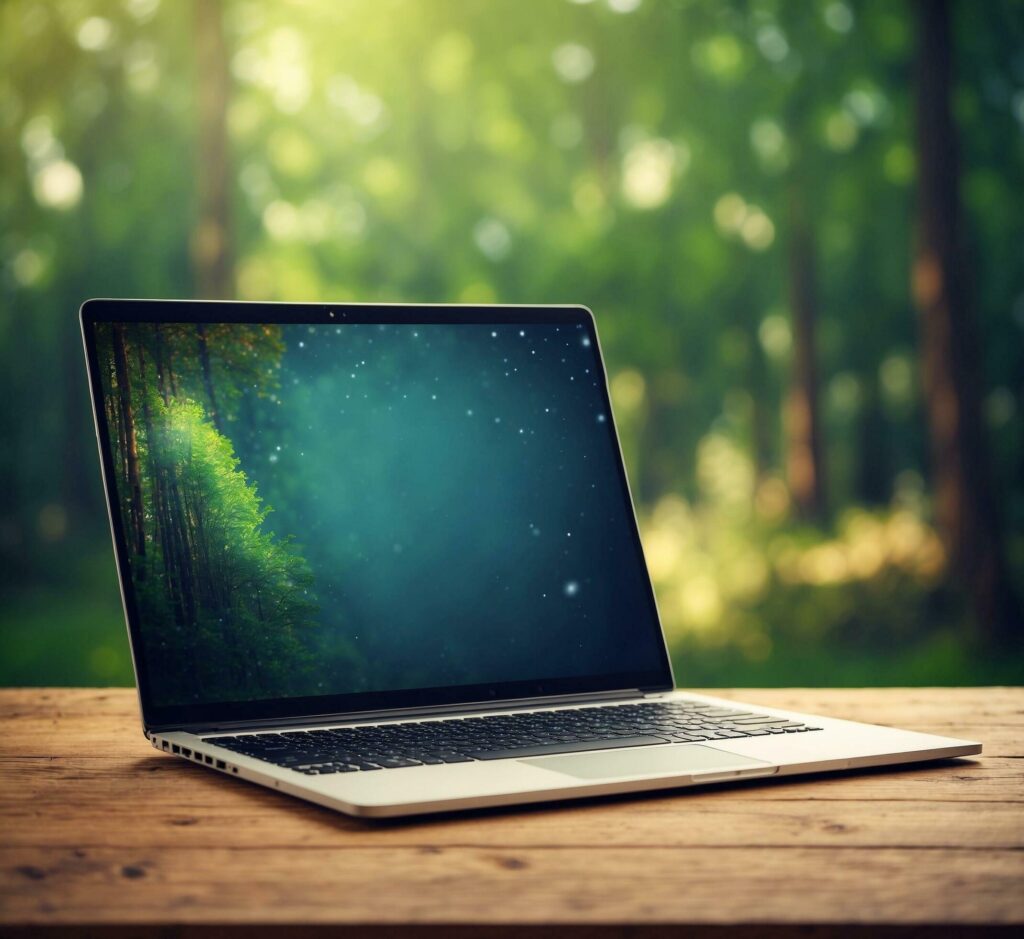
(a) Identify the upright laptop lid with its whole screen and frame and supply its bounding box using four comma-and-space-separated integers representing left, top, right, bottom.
81, 300, 672, 728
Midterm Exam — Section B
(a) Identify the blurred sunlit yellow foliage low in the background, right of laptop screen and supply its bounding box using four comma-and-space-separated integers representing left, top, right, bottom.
643, 432, 967, 663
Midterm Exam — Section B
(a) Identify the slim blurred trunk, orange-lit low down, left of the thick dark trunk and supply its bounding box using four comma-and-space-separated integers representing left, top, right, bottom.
785, 180, 825, 521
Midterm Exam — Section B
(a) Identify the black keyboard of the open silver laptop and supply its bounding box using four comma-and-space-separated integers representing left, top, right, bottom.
204, 699, 821, 775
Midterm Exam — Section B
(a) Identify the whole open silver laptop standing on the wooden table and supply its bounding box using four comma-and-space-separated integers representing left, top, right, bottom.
81, 300, 981, 817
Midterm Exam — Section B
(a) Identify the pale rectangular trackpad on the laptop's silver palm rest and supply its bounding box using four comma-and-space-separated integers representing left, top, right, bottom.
519, 743, 775, 779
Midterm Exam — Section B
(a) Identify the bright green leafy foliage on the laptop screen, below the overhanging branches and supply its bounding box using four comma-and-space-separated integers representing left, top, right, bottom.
134, 393, 316, 701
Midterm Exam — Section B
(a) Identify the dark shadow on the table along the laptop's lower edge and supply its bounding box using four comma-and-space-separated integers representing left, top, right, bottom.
128, 755, 981, 831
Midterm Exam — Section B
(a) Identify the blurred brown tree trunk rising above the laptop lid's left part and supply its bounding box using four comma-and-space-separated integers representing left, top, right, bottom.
191, 0, 233, 300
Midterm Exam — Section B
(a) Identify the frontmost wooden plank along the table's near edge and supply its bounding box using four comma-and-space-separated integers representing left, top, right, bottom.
0, 847, 1024, 926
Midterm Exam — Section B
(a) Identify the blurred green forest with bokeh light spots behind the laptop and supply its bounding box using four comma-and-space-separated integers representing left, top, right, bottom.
0, 0, 1024, 685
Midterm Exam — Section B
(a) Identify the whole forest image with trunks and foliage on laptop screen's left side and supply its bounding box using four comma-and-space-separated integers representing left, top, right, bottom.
98, 324, 327, 702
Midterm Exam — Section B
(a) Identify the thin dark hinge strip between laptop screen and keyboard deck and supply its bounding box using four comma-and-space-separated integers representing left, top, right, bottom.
153, 688, 645, 734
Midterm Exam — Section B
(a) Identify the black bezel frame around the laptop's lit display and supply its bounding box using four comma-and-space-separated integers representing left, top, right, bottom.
80, 300, 674, 730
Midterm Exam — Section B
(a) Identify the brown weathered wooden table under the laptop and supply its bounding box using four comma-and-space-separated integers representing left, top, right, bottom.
0, 688, 1024, 937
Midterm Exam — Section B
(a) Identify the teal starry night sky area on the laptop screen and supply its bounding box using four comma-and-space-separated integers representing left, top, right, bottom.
231, 324, 659, 693
